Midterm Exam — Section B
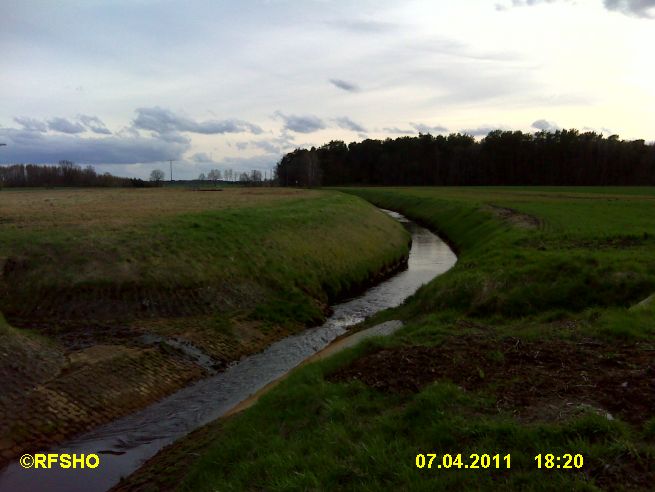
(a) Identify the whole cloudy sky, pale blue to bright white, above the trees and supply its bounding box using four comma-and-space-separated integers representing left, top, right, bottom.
0, 0, 655, 178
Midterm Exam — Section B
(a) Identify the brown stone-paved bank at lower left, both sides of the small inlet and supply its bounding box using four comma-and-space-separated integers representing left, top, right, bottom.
0, 316, 292, 468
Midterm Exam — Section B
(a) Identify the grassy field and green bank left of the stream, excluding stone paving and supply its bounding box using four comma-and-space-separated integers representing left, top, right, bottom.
0, 189, 408, 332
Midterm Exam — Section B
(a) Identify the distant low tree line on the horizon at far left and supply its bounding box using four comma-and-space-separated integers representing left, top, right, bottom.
0, 161, 152, 188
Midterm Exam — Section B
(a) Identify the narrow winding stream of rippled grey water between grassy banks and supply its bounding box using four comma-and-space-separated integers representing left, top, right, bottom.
0, 211, 457, 492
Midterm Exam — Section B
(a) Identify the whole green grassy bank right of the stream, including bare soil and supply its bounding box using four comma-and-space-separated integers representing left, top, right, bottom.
125, 188, 655, 490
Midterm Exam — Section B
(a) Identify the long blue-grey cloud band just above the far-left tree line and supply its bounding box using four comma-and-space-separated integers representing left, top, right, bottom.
0, 128, 190, 164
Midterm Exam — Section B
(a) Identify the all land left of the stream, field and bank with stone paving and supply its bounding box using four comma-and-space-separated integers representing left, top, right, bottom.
0, 188, 409, 465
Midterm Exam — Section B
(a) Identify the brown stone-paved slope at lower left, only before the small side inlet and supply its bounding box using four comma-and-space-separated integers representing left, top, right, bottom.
0, 327, 204, 467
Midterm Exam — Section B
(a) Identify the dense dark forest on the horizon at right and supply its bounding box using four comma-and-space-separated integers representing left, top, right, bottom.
276, 129, 655, 186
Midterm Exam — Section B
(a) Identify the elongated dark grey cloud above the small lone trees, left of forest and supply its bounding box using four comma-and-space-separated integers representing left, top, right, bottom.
133, 107, 263, 135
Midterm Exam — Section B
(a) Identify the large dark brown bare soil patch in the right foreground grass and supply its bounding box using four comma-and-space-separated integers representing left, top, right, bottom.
329, 336, 655, 424
